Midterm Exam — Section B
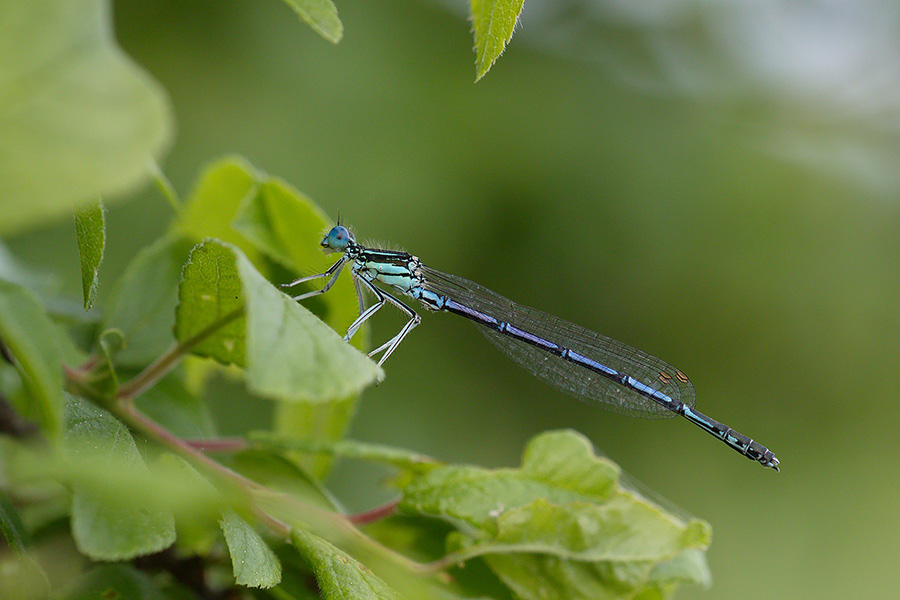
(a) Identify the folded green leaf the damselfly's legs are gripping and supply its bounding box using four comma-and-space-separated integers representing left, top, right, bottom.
175, 240, 382, 402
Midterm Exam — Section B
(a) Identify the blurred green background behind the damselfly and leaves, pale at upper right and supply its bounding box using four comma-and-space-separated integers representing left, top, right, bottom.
11, 0, 900, 600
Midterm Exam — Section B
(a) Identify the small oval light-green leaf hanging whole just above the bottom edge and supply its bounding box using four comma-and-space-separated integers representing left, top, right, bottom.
220, 511, 281, 588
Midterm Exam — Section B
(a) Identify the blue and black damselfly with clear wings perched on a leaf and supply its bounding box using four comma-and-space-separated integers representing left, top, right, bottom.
286, 225, 778, 471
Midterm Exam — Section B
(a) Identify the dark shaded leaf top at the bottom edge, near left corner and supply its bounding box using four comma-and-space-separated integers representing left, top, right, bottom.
50, 563, 167, 600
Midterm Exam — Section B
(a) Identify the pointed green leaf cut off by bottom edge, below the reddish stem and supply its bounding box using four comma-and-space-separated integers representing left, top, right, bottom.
291, 529, 400, 600
